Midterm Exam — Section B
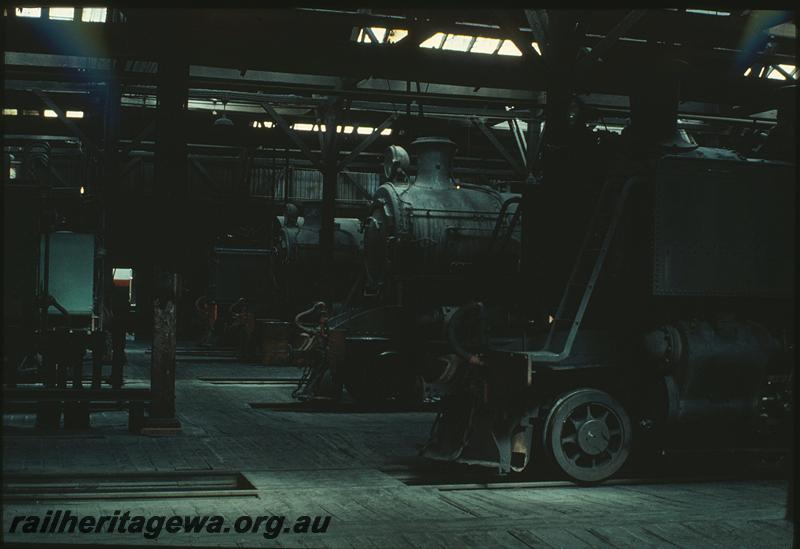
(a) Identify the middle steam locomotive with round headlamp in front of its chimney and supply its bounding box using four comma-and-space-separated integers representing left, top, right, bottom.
332, 137, 520, 401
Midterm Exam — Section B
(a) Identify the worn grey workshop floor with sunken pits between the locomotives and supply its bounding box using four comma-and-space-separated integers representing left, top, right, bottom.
3, 345, 792, 549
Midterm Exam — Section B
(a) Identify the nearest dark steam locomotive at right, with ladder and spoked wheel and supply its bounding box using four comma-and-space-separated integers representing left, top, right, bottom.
423, 70, 796, 483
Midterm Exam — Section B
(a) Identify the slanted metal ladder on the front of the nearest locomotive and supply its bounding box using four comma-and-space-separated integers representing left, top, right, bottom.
526, 177, 636, 362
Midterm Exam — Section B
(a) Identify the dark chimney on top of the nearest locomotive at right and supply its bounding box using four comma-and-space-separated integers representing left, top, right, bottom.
630, 59, 696, 149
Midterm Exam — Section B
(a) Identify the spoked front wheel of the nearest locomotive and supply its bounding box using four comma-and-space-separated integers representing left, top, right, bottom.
544, 389, 631, 483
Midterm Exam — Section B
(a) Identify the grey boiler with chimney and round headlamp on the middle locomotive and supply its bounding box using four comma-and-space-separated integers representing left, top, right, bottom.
364, 137, 519, 301
